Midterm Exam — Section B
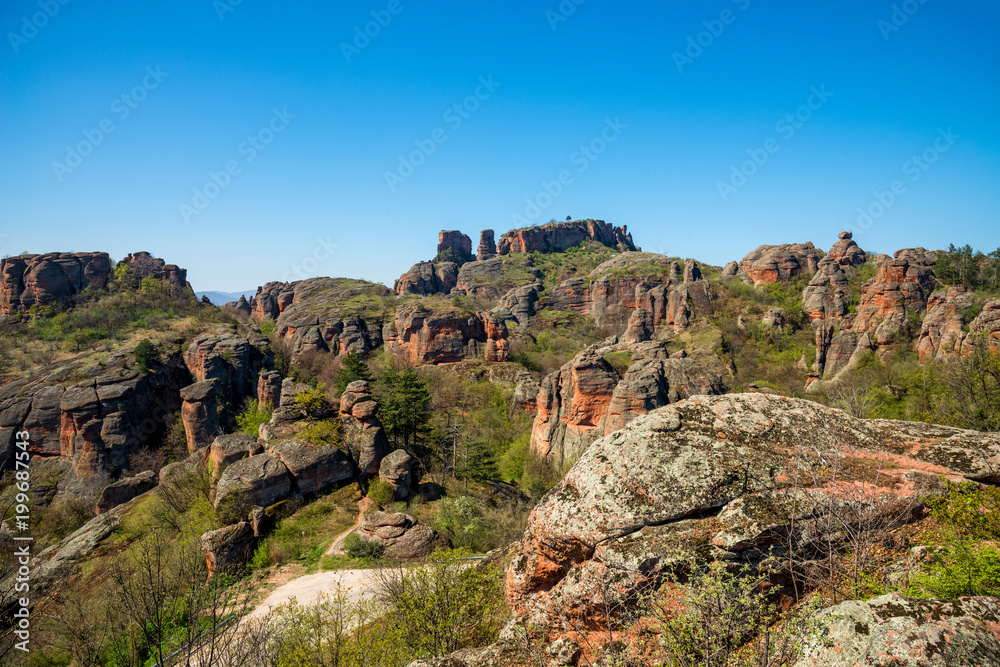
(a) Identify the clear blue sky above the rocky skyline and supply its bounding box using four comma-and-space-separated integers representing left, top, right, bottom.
0, 0, 1000, 291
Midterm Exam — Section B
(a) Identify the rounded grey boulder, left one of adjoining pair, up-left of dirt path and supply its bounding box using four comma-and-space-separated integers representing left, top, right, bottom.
215, 453, 292, 514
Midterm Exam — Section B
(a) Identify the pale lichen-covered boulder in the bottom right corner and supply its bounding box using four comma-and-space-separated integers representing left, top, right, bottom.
795, 593, 1000, 667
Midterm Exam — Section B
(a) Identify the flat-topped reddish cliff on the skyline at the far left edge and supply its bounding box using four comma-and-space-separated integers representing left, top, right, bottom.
0, 252, 111, 315
